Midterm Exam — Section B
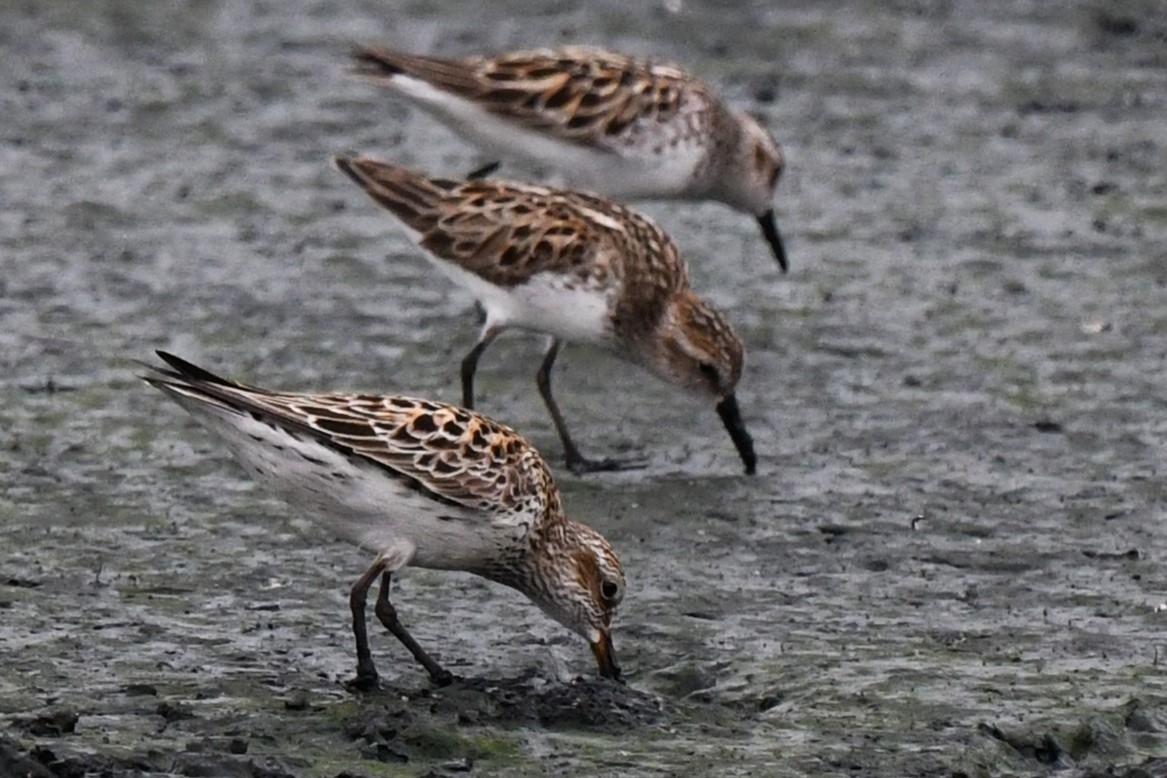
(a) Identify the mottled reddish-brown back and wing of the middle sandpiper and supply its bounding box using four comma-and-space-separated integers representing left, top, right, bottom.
334, 156, 687, 293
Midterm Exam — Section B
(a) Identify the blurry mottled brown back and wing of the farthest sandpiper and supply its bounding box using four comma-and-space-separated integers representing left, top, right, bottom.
355, 47, 715, 154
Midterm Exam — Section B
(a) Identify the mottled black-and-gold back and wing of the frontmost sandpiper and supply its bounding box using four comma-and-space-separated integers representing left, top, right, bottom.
147, 352, 558, 523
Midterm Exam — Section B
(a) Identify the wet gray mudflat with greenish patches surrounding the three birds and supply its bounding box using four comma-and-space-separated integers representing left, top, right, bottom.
0, 0, 1167, 778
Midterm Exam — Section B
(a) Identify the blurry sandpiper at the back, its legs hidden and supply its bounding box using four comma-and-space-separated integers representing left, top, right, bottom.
343, 45, 787, 272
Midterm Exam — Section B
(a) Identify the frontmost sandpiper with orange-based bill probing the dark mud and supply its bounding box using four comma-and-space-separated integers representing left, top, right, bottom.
142, 351, 624, 688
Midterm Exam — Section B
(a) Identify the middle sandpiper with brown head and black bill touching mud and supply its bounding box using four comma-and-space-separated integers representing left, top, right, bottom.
333, 156, 757, 474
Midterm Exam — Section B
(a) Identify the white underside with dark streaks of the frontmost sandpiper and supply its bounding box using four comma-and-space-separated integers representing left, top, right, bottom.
164, 390, 530, 569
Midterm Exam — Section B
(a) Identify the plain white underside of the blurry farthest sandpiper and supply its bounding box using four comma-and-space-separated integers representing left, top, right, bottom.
387, 75, 706, 199
